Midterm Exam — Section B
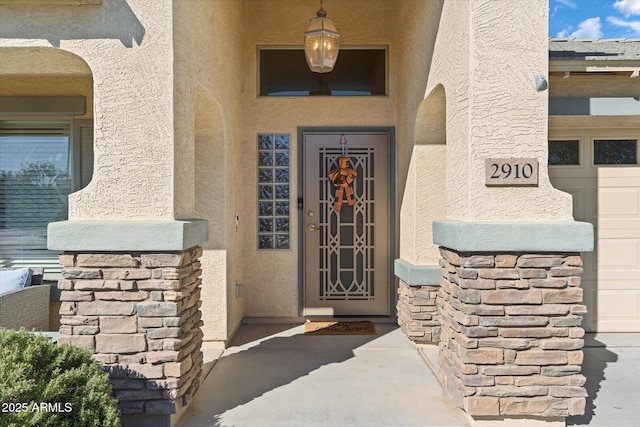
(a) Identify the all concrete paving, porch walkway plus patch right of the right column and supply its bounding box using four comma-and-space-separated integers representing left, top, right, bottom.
177, 323, 640, 427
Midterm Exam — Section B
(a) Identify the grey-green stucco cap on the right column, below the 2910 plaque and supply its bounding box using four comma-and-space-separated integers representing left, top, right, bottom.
433, 220, 593, 252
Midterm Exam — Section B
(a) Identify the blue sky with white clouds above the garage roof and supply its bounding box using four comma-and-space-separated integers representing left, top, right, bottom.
549, 0, 640, 39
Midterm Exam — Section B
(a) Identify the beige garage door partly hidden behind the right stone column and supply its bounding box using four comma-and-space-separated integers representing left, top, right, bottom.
549, 129, 640, 332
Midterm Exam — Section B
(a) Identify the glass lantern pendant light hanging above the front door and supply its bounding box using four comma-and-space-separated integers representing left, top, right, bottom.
304, 0, 340, 73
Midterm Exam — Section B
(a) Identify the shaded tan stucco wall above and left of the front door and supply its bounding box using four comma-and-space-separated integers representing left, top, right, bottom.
242, 0, 400, 317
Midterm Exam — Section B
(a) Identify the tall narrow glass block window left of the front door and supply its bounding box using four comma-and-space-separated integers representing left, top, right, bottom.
258, 134, 291, 249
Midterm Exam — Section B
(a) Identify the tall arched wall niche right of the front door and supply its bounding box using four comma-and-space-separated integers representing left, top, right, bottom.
400, 85, 447, 265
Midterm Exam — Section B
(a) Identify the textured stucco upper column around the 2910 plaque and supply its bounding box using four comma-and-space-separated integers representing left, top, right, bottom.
427, 0, 572, 221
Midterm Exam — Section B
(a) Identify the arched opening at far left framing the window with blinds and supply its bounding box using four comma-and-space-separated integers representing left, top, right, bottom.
0, 47, 94, 330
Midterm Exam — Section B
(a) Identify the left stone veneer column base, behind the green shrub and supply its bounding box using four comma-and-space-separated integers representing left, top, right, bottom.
58, 246, 203, 425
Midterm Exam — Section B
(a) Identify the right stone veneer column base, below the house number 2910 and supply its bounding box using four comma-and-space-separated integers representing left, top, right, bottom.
438, 247, 587, 425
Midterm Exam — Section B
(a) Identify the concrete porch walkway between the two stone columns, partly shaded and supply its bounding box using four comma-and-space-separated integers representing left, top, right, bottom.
177, 323, 469, 427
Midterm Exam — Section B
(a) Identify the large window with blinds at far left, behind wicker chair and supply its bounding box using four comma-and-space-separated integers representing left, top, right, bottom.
0, 119, 93, 278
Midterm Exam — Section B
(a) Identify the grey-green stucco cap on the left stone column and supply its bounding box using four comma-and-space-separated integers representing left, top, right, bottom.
47, 219, 209, 252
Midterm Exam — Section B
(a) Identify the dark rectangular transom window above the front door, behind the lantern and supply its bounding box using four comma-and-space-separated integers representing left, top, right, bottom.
259, 48, 387, 96
